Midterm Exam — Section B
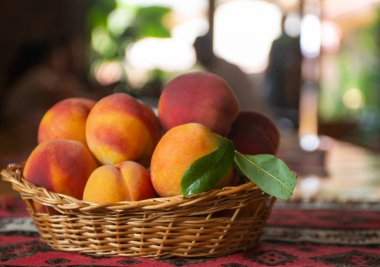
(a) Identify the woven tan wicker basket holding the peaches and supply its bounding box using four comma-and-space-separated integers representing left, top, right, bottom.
1, 164, 275, 258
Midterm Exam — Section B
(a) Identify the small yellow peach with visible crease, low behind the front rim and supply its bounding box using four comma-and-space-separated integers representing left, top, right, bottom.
83, 161, 156, 204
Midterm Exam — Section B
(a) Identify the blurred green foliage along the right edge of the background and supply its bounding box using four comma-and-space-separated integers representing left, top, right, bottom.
320, 6, 380, 147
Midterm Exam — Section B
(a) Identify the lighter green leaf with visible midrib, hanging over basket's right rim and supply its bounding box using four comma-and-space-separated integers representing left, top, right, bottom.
234, 151, 297, 200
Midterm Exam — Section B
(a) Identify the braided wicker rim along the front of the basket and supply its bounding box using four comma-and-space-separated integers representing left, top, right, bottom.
1, 163, 267, 212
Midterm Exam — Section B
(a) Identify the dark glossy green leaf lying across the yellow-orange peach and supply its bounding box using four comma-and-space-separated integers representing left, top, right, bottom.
181, 138, 234, 197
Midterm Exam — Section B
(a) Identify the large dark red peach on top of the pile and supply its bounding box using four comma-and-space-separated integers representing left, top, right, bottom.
158, 72, 239, 136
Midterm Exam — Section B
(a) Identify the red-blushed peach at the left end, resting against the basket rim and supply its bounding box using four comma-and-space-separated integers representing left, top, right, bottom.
23, 139, 98, 199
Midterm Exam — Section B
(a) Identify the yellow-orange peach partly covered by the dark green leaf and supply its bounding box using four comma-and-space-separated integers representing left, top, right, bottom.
150, 123, 234, 197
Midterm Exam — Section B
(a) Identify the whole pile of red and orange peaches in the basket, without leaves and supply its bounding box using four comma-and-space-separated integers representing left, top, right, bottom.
23, 72, 279, 203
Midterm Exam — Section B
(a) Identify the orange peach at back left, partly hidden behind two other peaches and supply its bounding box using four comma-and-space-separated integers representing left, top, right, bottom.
38, 97, 95, 144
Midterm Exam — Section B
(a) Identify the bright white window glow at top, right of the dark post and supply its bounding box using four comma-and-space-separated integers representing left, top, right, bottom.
214, 0, 281, 73
